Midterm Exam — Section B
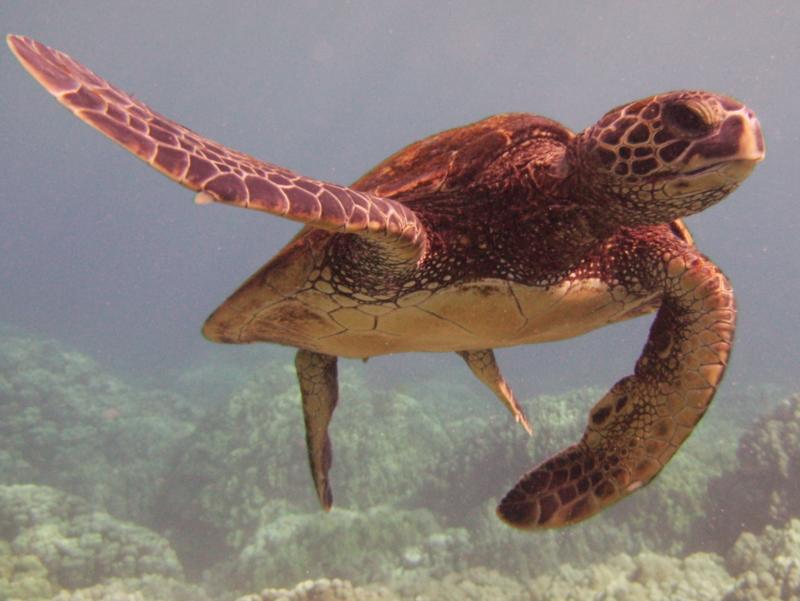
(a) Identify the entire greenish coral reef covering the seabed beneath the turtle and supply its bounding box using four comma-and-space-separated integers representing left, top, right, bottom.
0, 335, 800, 601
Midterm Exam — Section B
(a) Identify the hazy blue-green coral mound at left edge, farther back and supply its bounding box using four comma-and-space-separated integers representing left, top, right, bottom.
0, 336, 194, 523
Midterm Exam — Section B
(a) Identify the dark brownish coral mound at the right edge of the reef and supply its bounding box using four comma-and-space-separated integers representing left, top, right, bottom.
692, 395, 800, 553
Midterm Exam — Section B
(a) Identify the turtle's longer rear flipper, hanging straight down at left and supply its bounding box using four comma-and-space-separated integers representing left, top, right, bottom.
295, 350, 339, 511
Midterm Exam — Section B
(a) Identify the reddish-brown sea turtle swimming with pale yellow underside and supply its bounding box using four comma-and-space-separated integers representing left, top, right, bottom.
8, 36, 764, 529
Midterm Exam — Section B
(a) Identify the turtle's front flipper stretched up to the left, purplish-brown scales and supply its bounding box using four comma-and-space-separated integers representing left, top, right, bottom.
7, 35, 426, 265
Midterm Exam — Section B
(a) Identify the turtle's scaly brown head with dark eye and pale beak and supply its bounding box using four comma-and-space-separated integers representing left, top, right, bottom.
576, 91, 764, 225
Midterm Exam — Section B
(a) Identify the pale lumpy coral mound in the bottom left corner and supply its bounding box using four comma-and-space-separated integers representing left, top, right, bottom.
0, 485, 183, 588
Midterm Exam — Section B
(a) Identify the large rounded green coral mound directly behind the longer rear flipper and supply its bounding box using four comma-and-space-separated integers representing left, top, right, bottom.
157, 365, 452, 569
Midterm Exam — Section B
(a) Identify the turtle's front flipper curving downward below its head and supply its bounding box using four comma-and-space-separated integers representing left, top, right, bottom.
497, 252, 736, 529
